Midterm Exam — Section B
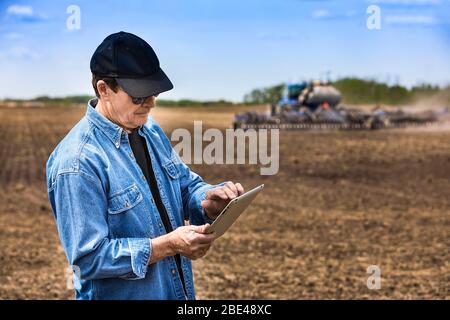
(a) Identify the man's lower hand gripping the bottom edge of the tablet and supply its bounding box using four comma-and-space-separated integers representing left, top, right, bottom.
167, 224, 216, 260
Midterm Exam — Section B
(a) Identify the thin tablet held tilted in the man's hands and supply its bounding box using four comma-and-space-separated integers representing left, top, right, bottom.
208, 184, 264, 238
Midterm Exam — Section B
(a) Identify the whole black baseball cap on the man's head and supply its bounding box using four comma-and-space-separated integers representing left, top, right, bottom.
90, 31, 173, 98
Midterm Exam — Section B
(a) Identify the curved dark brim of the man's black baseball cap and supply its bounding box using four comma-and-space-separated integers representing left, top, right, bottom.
116, 68, 173, 98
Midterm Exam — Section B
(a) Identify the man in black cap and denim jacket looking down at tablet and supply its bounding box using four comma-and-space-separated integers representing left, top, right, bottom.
47, 32, 244, 299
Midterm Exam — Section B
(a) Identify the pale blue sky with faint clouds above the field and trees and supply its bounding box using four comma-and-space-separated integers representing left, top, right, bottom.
0, 0, 450, 101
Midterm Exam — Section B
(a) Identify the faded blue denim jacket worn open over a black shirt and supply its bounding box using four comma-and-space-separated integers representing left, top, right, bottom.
46, 100, 219, 299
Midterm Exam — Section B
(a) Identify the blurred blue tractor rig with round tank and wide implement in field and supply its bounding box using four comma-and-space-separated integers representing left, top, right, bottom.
233, 81, 450, 130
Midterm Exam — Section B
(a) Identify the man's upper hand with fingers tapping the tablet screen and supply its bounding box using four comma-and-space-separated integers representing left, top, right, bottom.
201, 181, 244, 220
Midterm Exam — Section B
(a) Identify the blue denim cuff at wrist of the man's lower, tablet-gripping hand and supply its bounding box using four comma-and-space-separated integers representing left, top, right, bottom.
128, 238, 152, 279
